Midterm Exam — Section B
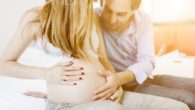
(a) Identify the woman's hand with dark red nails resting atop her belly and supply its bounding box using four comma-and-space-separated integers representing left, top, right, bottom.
45, 62, 84, 85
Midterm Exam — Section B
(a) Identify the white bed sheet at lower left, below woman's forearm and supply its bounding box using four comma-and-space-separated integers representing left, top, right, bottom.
0, 76, 46, 110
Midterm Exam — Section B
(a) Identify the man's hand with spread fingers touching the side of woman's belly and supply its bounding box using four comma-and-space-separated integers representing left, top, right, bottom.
92, 71, 121, 100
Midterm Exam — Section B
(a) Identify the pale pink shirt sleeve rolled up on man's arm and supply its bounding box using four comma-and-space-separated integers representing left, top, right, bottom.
127, 13, 155, 84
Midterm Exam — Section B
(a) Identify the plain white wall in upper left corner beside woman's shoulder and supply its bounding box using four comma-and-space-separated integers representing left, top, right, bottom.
0, 0, 44, 56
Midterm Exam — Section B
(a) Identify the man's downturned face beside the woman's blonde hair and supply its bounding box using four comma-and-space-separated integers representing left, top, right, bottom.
101, 0, 133, 31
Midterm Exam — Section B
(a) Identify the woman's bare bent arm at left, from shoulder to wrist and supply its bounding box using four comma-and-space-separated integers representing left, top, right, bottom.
0, 10, 45, 79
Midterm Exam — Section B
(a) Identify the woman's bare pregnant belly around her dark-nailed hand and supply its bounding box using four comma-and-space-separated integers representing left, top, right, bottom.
47, 60, 106, 104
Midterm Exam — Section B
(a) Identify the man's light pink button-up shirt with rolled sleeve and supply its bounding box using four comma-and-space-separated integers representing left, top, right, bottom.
99, 10, 155, 84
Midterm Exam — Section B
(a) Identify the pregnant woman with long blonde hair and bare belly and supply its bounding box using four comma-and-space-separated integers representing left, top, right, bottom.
0, 0, 122, 110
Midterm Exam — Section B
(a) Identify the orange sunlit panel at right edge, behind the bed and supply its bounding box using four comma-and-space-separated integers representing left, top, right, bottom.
154, 22, 195, 56
